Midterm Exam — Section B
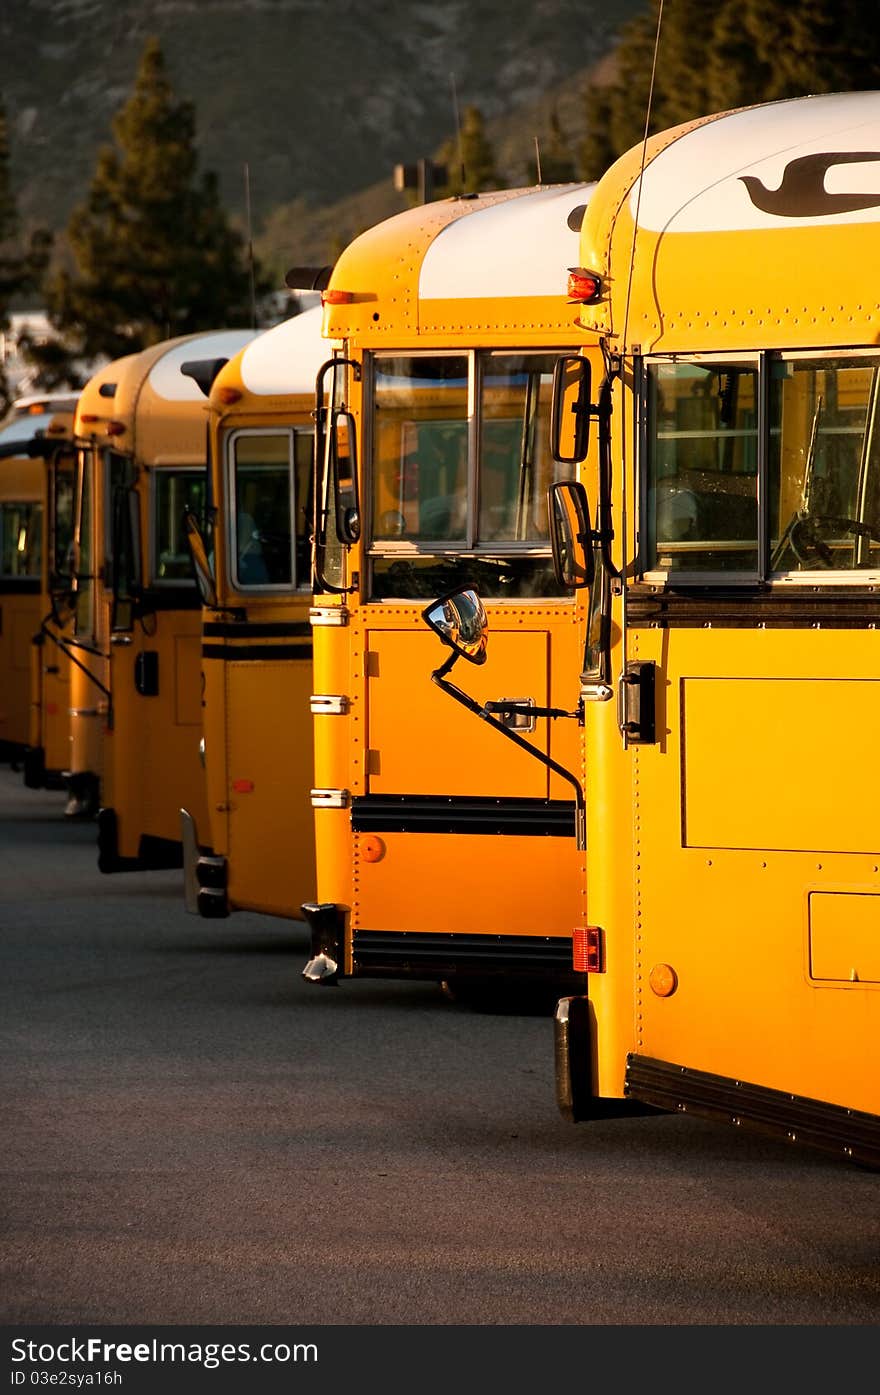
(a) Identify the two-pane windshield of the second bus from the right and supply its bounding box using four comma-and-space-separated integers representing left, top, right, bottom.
370, 352, 561, 598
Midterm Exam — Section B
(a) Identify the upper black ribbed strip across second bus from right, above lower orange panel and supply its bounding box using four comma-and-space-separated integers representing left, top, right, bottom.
351, 794, 576, 838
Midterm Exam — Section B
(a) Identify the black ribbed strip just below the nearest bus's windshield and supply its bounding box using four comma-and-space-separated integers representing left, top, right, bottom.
626, 586, 880, 629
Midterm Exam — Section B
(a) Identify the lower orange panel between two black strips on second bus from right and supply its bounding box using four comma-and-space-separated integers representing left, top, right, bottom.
351, 833, 583, 936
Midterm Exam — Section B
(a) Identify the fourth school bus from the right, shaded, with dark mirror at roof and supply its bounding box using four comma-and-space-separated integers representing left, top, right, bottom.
71, 329, 254, 872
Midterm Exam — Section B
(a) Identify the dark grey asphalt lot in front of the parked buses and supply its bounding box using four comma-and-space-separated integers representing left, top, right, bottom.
0, 766, 880, 1327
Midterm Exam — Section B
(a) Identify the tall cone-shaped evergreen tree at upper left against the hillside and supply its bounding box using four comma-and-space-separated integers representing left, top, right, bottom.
35, 38, 266, 371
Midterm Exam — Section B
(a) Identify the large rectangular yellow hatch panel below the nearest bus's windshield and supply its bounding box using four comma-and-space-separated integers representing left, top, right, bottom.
682, 678, 880, 852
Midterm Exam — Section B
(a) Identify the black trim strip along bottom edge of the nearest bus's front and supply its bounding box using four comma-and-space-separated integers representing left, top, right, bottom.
623, 1055, 880, 1168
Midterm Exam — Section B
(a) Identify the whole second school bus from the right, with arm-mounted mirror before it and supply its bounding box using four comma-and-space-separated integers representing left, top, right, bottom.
303, 184, 598, 1000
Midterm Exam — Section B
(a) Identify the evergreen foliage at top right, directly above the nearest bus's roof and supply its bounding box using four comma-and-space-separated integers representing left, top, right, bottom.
580, 0, 880, 179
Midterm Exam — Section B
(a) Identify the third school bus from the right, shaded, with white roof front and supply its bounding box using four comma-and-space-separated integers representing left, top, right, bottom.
180, 306, 328, 917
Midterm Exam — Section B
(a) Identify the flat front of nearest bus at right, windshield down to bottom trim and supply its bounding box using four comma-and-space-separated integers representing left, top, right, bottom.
627, 352, 880, 1147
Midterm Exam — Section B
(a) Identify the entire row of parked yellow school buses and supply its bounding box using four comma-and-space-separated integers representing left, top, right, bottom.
0, 92, 880, 1166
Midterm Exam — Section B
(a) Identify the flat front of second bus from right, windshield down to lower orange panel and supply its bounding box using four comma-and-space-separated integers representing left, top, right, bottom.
351, 350, 579, 953
